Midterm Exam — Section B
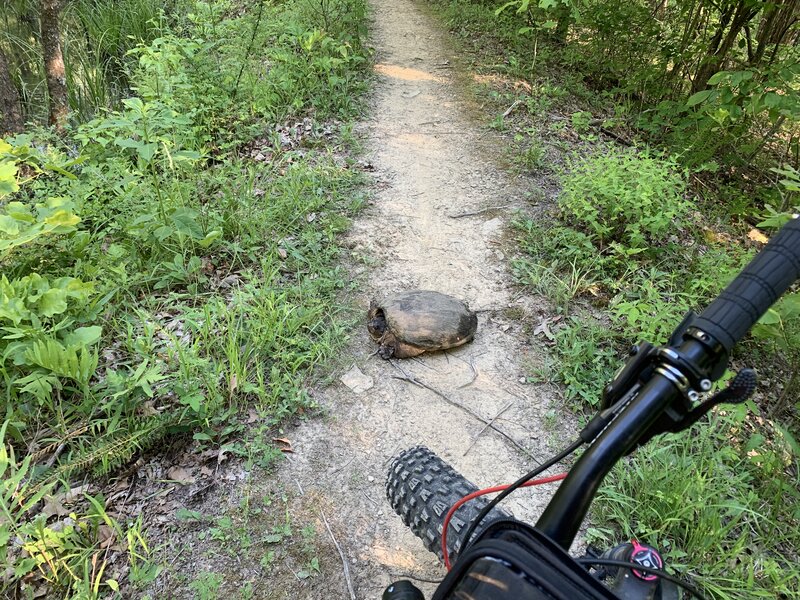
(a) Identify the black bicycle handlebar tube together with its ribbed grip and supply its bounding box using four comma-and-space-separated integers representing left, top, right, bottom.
536, 219, 800, 549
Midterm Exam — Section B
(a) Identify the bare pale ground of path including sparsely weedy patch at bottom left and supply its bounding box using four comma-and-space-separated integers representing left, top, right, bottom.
145, 0, 560, 600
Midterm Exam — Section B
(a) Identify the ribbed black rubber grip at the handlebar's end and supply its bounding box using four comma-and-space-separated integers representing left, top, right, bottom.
692, 218, 800, 354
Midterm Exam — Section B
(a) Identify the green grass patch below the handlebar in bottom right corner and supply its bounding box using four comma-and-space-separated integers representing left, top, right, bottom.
590, 413, 800, 599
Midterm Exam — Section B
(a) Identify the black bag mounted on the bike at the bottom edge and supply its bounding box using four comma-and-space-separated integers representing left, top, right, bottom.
433, 520, 618, 600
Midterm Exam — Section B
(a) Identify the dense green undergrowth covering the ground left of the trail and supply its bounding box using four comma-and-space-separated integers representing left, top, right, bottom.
0, 0, 367, 598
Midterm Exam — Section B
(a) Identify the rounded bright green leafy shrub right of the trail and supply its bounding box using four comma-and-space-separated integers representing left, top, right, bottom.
558, 149, 690, 249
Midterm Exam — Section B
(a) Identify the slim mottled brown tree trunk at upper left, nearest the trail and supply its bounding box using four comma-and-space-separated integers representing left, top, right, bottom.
40, 0, 69, 130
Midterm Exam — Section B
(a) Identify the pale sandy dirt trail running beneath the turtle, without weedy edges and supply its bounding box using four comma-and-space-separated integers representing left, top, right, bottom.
276, 0, 564, 599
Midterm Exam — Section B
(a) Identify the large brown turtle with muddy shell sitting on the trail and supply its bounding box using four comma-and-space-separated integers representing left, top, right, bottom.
367, 290, 478, 359
